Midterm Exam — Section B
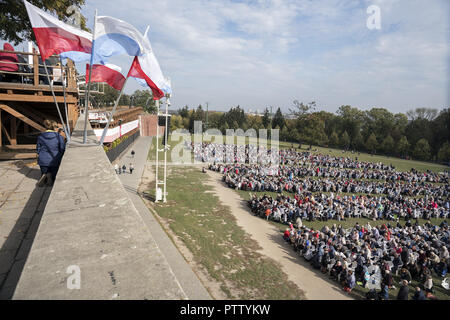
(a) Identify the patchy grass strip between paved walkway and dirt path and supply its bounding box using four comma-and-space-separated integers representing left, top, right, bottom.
147, 166, 304, 299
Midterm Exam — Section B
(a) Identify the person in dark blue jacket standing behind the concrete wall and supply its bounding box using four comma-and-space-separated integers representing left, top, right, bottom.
36, 120, 66, 187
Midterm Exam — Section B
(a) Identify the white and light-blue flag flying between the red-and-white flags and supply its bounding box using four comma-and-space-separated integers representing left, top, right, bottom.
93, 16, 143, 65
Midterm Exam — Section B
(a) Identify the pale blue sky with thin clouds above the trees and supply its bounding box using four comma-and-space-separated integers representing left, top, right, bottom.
7, 0, 450, 112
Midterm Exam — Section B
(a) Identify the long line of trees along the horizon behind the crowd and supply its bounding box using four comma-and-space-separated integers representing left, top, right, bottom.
171, 100, 450, 163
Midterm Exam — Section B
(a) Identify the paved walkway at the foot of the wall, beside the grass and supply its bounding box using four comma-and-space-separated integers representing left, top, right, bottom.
113, 137, 211, 300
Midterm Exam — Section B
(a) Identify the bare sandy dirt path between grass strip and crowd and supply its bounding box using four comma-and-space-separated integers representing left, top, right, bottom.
205, 170, 352, 300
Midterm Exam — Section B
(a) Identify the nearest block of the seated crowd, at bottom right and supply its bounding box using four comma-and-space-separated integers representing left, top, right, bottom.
276, 221, 450, 300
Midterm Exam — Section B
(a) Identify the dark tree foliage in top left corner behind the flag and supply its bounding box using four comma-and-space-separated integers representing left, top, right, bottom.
0, 0, 88, 45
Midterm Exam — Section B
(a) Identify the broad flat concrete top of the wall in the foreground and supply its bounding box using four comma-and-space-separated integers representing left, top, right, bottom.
13, 117, 187, 300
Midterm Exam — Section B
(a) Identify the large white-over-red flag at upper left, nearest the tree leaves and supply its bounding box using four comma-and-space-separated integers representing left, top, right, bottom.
23, 0, 92, 61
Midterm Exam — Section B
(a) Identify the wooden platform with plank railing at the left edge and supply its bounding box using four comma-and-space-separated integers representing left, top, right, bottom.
0, 50, 79, 160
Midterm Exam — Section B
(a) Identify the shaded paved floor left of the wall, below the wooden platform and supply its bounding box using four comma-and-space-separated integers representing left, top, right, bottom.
0, 161, 51, 300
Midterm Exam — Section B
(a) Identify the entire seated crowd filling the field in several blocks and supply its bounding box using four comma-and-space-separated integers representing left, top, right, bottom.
201, 143, 450, 300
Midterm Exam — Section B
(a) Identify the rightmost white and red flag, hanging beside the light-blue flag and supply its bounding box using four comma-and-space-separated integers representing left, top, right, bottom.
128, 31, 172, 100
